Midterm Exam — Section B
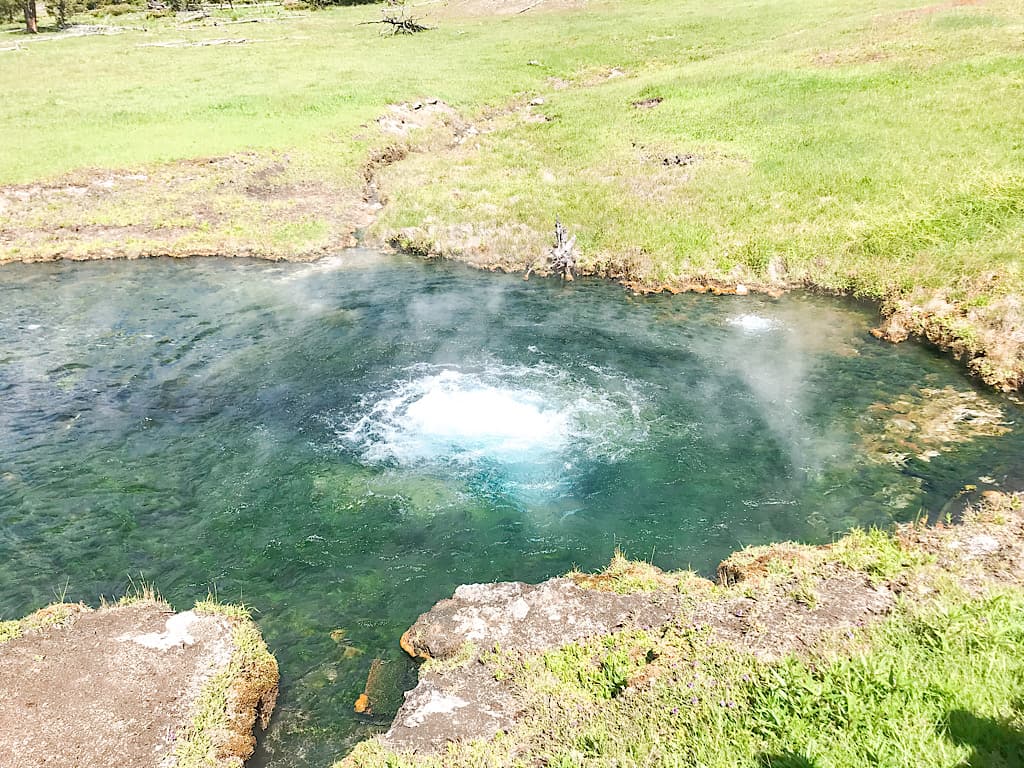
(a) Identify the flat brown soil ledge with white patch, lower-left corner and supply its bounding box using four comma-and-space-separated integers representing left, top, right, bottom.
0, 599, 278, 768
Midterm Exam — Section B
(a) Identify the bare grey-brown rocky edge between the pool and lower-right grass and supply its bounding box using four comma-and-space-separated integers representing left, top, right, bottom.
339, 492, 1024, 768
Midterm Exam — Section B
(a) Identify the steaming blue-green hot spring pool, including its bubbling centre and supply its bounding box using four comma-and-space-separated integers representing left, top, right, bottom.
0, 251, 1024, 766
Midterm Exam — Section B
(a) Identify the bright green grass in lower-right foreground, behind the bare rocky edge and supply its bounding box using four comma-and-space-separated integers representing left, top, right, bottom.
345, 590, 1024, 768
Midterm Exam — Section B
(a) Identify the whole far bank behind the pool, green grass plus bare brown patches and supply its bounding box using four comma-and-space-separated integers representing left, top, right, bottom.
0, 0, 1024, 389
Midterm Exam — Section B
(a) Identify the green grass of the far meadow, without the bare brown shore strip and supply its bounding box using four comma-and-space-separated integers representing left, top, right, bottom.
0, 0, 1024, 290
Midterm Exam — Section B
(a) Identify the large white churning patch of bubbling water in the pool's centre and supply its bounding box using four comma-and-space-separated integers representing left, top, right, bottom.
338, 364, 646, 470
